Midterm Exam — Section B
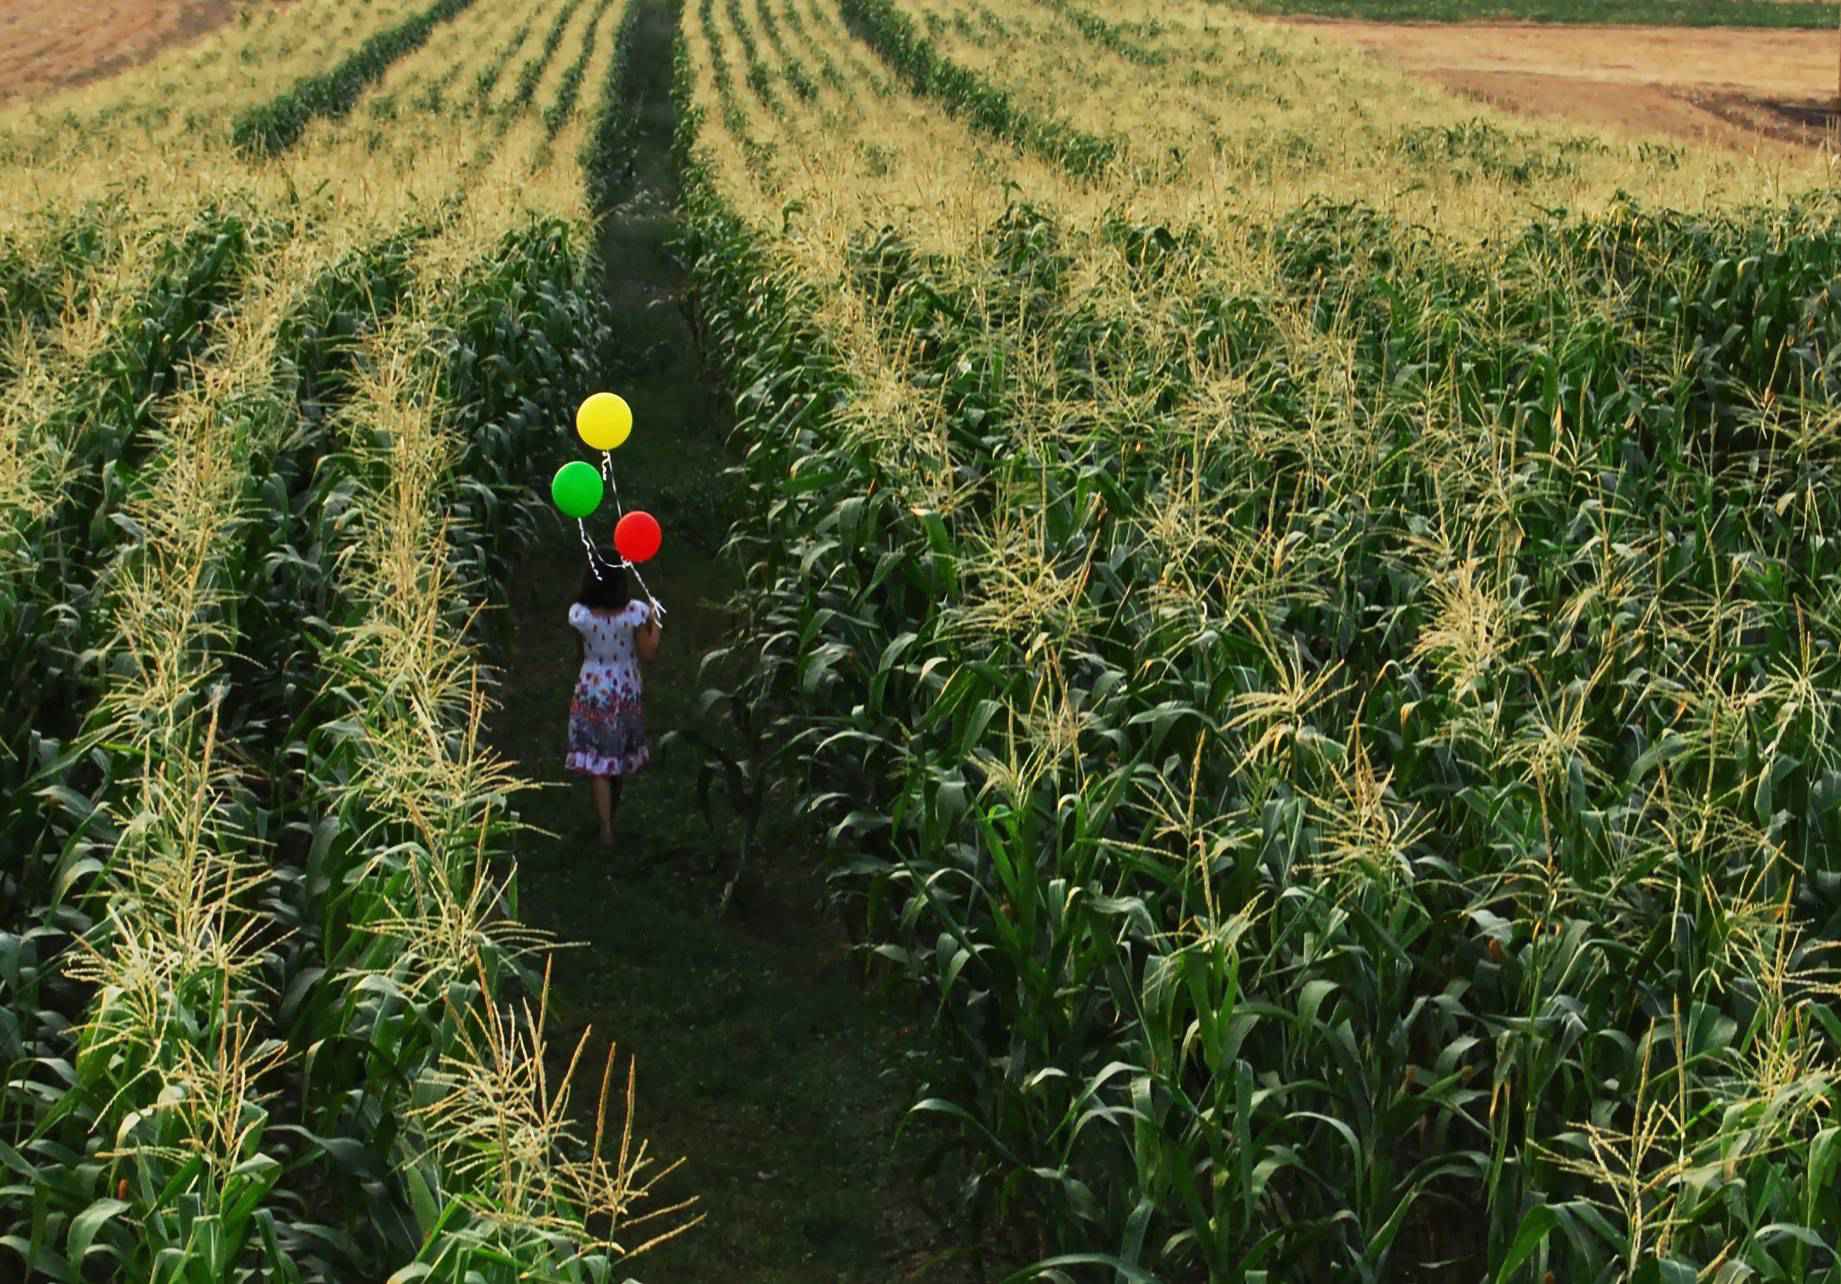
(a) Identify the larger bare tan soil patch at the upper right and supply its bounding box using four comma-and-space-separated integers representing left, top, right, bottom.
1291, 18, 1837, 151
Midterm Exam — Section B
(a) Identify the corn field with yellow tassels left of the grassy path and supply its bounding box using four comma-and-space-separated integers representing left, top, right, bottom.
0, 0, 687, 1284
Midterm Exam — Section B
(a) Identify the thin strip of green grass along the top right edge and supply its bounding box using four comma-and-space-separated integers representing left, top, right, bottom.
1235, 0, 1835, 28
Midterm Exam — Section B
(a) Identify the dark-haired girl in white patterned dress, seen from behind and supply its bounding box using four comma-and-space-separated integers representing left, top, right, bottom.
563, 553, 659, 847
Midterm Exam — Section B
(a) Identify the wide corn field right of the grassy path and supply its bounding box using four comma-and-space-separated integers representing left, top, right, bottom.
674, 0, 1841, 1284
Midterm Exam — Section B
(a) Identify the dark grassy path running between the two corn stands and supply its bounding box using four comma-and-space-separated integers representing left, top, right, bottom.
490, 0, 961, 1284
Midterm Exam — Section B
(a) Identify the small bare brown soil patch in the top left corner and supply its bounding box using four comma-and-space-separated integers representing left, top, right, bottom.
0, 0, 261, 103
